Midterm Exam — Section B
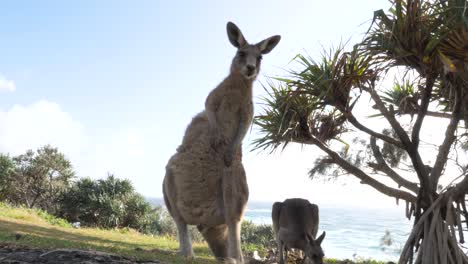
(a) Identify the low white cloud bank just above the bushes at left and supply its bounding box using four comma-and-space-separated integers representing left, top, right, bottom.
0, 101, 151, 191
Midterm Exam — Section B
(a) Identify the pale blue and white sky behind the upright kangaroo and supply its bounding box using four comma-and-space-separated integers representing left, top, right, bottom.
0, 0, 410, 205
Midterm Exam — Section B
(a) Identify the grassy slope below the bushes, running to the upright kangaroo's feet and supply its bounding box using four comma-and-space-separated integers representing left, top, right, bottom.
0, 203, 217, 264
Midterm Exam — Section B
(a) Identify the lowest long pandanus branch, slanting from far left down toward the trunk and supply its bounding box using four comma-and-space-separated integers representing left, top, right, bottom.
298, 137, 416, 202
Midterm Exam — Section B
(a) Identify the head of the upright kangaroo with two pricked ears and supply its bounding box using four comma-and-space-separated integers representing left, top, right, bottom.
227, 22, 281, 80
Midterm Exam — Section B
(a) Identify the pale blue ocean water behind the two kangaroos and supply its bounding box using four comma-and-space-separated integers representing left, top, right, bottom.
150, 199, 411, 261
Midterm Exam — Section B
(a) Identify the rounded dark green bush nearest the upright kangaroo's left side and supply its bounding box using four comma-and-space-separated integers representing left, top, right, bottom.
60, 175, 157, 231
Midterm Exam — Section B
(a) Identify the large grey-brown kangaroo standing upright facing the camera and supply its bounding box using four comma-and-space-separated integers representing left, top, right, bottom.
163, 22, 280, 263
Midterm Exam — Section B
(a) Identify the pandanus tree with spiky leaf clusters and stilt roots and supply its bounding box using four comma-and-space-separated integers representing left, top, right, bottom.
254, 0, 468, 263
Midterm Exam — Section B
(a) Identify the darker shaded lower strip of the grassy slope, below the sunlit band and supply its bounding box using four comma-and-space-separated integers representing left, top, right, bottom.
0, 219, 216, 263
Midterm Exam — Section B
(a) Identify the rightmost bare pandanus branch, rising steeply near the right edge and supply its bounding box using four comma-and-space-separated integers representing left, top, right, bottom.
431, 87, 462, 191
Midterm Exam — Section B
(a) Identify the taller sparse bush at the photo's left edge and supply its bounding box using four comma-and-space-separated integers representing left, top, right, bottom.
0, 145, 75, 214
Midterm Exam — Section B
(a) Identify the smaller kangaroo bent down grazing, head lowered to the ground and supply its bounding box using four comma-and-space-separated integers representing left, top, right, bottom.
271, 198, 325, 264
